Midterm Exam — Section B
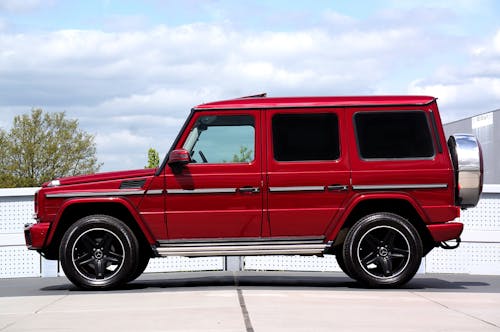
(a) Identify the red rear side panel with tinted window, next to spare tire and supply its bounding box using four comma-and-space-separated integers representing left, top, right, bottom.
346, 104, 455, 217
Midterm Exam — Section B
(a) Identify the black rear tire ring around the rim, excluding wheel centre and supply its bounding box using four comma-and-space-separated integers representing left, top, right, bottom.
343, 213, 422, 287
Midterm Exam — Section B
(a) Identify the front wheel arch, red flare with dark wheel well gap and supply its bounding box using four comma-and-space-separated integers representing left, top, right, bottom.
44, 197, 154, 259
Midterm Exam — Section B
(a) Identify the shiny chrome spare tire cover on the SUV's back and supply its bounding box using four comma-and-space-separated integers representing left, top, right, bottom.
448, 134, 483, 209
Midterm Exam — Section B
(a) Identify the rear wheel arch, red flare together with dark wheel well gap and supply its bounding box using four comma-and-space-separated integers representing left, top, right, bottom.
327, 193, 435, 256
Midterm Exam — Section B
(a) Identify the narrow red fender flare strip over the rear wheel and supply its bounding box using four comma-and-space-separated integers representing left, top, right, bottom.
326, 192, 429, 241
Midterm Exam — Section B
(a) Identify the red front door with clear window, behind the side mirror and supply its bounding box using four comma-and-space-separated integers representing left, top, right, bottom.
166, 110, 263, 239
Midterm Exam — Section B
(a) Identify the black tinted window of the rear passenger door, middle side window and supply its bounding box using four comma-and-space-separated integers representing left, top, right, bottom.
272, 113, 340, 161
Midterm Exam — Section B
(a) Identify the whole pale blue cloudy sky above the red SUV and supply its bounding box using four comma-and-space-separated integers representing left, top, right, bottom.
0, 0, 500, 171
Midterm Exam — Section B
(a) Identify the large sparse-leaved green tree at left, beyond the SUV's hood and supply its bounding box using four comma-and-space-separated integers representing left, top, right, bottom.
0, 109, 101, 187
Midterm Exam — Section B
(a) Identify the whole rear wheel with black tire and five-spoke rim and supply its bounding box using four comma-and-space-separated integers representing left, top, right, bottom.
343, 212, 422, 287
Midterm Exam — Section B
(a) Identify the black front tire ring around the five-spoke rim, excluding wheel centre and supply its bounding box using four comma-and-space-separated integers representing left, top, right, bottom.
59, 215, 139, 289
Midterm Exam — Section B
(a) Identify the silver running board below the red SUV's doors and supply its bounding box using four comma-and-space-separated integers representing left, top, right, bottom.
156, 238, 329, 257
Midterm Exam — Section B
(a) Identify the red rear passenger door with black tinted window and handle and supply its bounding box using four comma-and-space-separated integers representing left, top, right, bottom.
266, 108, 350, 237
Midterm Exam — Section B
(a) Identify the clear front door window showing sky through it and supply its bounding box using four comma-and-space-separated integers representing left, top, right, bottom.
183, 115, 255, 164
